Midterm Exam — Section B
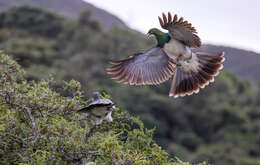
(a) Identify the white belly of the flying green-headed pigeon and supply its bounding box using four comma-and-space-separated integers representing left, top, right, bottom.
163, 39, 191, 59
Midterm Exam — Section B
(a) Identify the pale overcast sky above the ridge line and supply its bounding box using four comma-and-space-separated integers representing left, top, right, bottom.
86, 0, 260, 52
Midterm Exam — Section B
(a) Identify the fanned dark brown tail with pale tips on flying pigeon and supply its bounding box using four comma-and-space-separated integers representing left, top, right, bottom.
169, 52, 225, 98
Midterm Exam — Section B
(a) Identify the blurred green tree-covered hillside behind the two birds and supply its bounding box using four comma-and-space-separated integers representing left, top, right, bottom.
0, 6, 260, 165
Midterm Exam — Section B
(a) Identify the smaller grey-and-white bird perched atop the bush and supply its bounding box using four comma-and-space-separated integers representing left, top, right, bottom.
78, 92, 115, 125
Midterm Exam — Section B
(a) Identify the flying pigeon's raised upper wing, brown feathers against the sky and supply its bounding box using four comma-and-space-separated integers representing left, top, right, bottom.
159, 13, 201, 48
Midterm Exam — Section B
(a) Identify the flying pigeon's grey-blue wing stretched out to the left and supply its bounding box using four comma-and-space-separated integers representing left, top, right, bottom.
107, 47, 176, 85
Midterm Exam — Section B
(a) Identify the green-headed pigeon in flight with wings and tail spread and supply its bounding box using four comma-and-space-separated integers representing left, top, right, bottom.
107, 13, 225, 98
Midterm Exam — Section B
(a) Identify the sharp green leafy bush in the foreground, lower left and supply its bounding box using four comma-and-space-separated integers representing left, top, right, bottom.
0, 54, 201, 165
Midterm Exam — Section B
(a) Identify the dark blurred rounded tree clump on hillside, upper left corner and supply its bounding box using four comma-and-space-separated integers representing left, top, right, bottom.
0, 6, 63, 37
